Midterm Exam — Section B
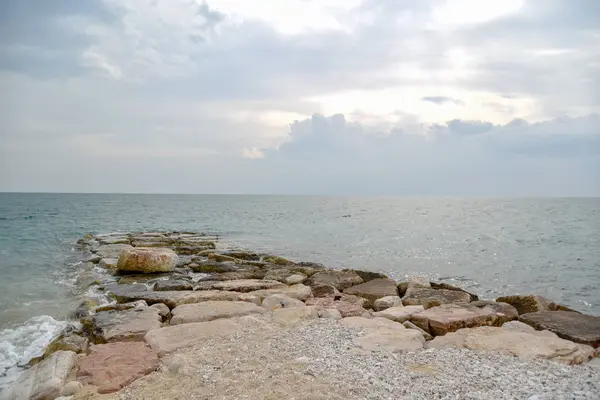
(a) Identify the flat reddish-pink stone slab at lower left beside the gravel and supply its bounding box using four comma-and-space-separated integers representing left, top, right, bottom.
77, 342, 158, 393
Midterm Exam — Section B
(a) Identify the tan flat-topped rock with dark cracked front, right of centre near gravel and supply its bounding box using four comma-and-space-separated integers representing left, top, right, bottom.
410, 304, 498, 336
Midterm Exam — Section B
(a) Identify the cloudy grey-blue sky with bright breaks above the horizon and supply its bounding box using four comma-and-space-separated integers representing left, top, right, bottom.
0, 0, 600, 196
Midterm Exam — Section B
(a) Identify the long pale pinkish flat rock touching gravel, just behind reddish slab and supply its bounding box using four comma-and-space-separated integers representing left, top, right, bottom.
144, 319, 241, 357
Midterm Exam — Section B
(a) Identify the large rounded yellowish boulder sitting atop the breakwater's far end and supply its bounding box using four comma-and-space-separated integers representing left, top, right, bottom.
117, 247, 177, 273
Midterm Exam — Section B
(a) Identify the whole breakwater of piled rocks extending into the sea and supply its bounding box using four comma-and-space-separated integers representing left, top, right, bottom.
8, 232, 600, 399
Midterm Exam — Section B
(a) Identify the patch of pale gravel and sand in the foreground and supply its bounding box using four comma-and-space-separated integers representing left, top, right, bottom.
118, 317, 600, 400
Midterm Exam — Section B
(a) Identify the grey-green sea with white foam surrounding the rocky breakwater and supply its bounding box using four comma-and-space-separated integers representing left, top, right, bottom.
0, 193, 600, 388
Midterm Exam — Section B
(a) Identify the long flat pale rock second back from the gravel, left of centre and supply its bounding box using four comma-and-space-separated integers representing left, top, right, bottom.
171, 301, 266, 325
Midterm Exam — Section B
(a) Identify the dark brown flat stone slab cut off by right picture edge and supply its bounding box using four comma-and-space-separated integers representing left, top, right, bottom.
519, 311, 600, 348
